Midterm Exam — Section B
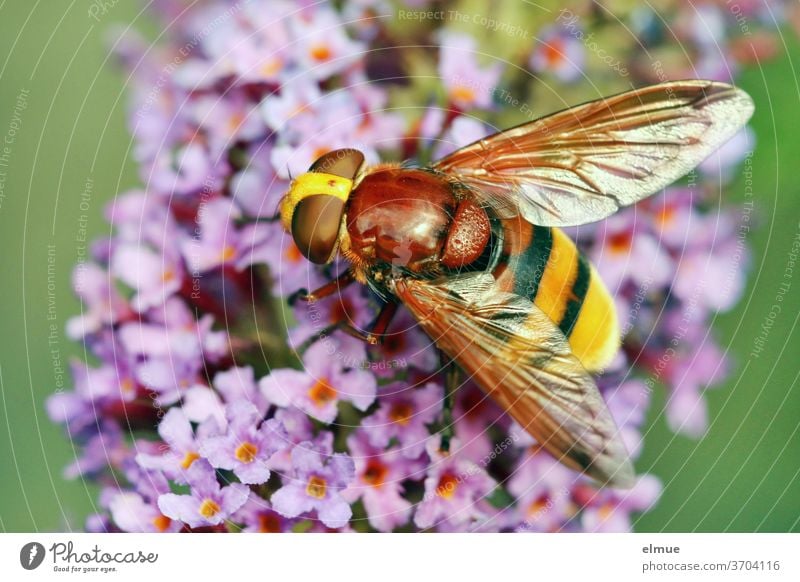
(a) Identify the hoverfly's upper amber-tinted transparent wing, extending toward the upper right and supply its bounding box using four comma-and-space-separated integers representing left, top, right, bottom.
433, 80, 753, 226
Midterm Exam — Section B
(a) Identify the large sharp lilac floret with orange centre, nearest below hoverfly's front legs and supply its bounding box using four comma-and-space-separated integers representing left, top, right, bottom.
259, 341, 375, 423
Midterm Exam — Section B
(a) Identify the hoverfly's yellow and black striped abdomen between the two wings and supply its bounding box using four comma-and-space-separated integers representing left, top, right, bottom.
494, 219, 619, 371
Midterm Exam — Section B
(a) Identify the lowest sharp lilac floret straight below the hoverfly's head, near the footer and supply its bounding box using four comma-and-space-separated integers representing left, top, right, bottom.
272, 441, 355, 528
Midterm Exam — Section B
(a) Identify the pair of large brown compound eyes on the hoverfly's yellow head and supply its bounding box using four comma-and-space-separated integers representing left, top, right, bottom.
292, 149, 364, 265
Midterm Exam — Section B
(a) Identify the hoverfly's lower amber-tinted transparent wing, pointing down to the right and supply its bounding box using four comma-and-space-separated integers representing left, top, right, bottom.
394, 273, 634, 487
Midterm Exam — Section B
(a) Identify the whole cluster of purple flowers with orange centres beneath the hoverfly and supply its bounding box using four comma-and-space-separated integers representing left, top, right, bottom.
48, 0, 780, 532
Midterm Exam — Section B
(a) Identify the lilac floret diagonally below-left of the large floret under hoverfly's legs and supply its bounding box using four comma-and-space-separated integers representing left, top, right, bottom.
200, 400, 288, 485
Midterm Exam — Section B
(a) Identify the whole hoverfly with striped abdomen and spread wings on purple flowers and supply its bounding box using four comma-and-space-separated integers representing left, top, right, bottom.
280, 80, 753, 487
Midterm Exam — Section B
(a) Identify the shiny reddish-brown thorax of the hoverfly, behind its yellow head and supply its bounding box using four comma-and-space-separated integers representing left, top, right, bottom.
347, 168, 491, 272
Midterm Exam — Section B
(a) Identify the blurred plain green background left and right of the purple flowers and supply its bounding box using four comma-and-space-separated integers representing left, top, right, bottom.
0, 1, 800, 531
